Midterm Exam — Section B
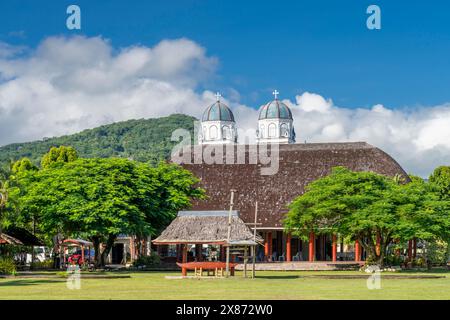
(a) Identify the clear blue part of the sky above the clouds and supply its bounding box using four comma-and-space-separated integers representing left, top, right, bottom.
0, 0, 450, 108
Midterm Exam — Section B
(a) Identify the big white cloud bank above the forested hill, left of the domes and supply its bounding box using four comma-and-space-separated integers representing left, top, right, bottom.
0, 36, 217, 145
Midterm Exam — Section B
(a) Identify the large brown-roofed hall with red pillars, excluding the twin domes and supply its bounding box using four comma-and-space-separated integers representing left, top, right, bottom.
174, 142, 408, 260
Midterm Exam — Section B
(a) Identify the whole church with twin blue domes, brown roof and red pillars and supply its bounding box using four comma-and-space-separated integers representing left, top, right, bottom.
176, 91, 407, 261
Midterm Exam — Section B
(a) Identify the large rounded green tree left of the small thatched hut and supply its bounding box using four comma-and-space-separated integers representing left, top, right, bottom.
21, 158, 203, 266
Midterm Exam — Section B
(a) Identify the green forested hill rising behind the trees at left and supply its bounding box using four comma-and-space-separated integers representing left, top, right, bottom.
0, 114, 196, 164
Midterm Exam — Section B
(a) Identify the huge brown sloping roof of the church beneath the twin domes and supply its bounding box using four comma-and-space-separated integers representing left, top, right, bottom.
178, 142, 408, 228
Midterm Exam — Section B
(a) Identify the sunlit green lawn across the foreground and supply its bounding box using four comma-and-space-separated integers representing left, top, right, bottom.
0, 271, 450, 300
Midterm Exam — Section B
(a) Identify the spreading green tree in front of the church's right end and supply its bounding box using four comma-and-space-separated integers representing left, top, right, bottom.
284, 167, 445, 265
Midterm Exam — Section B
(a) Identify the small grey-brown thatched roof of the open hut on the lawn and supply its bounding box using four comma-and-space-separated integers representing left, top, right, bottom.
153, 210, 263, 245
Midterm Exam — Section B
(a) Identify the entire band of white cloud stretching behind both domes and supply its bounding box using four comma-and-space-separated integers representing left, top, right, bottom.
0, 36, 450, 176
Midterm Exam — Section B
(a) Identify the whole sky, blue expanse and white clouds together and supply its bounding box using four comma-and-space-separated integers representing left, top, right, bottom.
0, 0, 450, 177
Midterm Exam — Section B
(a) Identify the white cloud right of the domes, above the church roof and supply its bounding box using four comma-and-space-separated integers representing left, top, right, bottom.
285, 92, 450, 177
